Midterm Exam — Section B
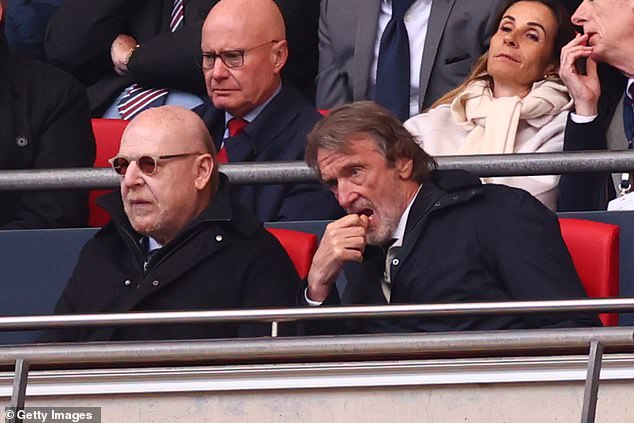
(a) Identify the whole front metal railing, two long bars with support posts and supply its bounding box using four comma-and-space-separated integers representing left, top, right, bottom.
0, 298, 634, 423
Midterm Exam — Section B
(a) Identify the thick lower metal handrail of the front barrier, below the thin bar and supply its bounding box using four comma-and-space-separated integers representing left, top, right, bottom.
0, 327, 634, 366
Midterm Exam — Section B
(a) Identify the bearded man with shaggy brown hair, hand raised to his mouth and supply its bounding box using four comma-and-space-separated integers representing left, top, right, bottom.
303, 101, 600, 332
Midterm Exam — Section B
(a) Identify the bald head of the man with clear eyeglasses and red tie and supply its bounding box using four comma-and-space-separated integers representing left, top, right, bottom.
201, 0, 288, 117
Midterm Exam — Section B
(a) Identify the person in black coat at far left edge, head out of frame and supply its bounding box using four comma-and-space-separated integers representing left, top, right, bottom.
0, 1, 95, 229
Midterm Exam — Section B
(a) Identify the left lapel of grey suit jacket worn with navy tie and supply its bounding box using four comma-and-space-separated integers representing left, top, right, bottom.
351, 0, 381, 100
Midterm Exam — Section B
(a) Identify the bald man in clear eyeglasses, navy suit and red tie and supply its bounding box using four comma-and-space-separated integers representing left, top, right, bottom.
199, 0, 343, 221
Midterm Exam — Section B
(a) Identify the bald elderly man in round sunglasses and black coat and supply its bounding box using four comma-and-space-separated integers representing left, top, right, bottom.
47, 106, 299, 341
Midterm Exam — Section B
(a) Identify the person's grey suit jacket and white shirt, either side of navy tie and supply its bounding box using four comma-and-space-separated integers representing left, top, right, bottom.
317, 0, 506, 116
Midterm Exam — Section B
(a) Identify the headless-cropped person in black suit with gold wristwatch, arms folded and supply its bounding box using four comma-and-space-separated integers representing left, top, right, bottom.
45, 0, 213, 118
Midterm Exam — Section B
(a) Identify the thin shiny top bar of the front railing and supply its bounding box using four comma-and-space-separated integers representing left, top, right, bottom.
0, 298, 634, 331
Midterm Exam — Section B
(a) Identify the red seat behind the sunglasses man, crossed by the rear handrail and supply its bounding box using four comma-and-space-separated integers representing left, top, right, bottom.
88, 118, 128, 227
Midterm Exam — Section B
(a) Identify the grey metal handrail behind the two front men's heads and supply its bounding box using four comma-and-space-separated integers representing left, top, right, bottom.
0, 151, 634, 191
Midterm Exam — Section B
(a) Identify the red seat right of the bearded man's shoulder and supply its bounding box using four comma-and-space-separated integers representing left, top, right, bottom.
559, 218, 619, 326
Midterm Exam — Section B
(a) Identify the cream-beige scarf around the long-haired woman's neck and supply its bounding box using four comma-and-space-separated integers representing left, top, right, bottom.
451, 80, 573, 155
